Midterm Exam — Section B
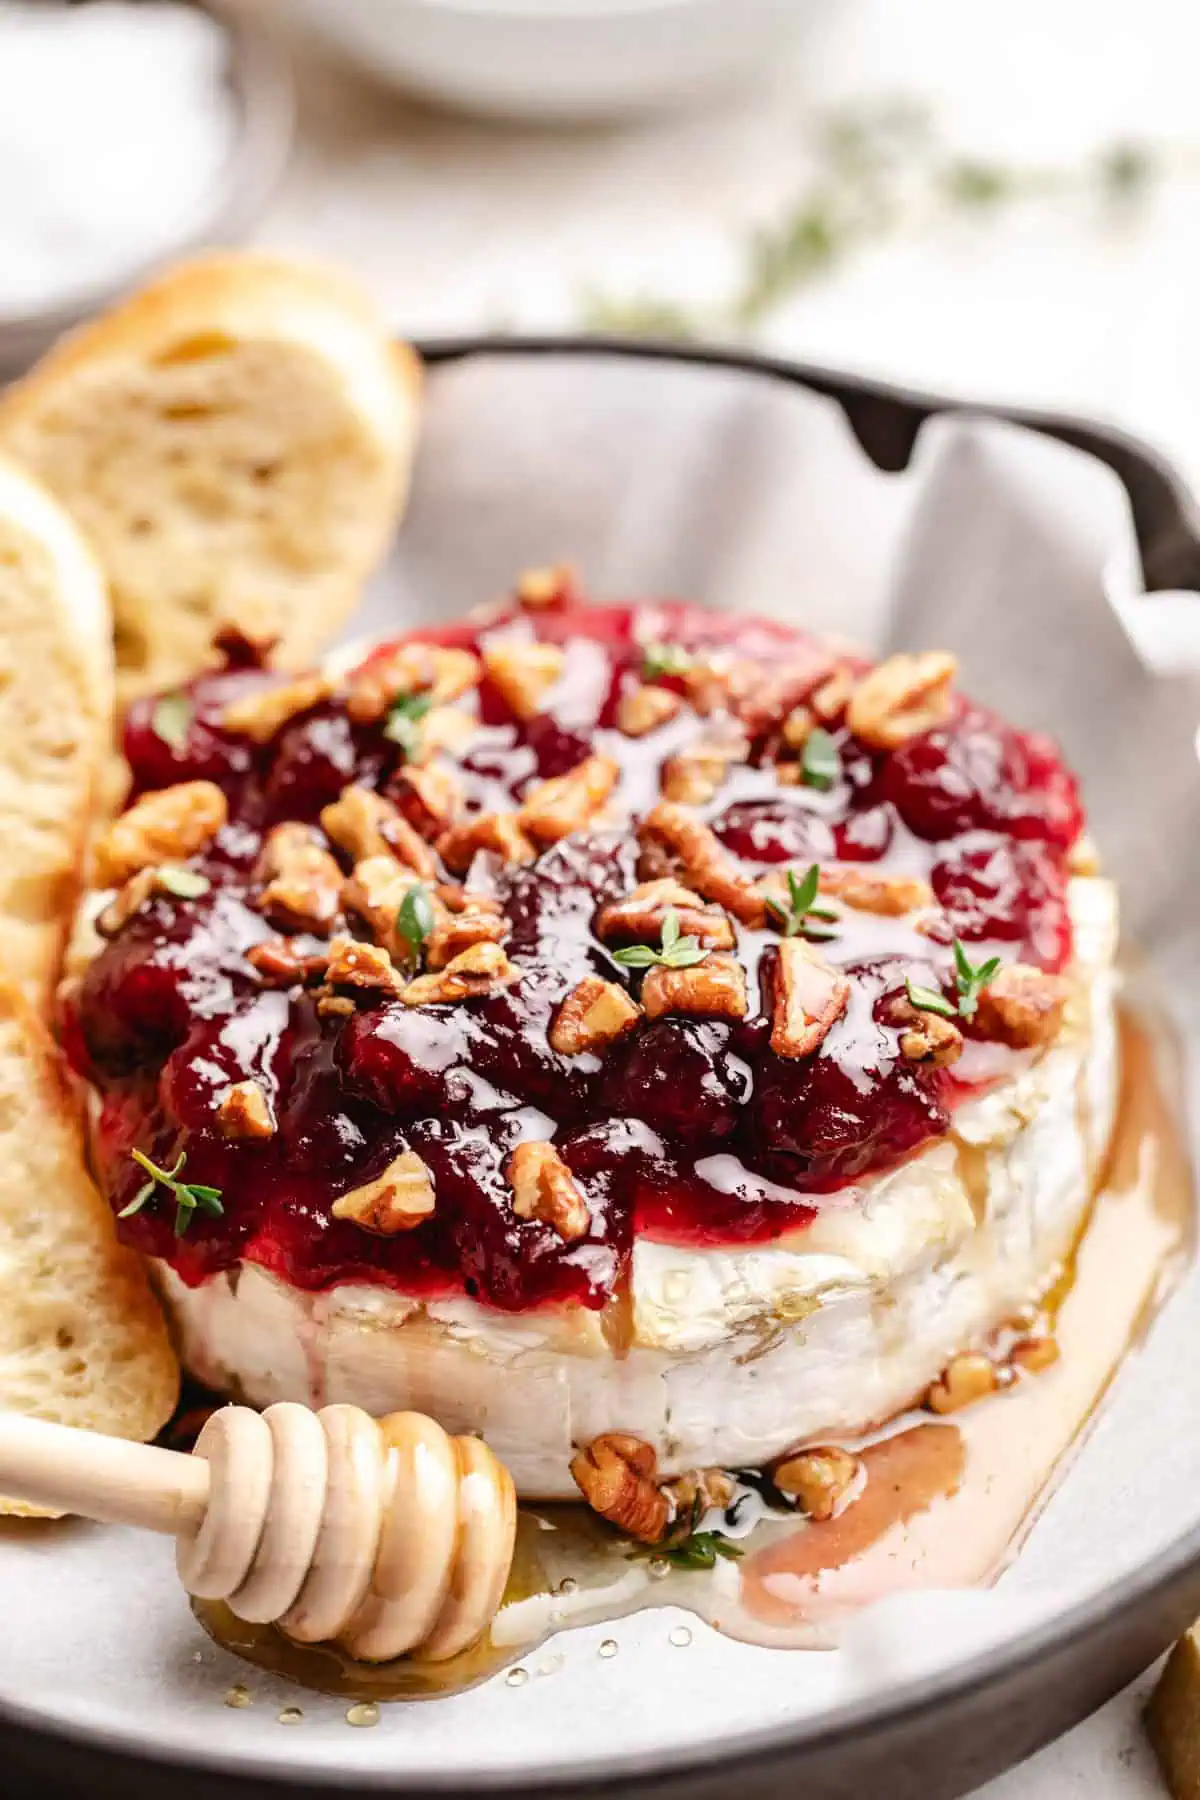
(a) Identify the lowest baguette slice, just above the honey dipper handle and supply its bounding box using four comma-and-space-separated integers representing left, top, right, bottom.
0, 983, 180, 1516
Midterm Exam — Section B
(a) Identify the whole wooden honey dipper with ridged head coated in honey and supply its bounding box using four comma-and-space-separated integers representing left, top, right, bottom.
0, 1400, 516, 1663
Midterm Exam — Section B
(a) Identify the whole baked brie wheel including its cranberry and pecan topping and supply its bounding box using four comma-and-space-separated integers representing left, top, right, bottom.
67, 574, 1117, 1498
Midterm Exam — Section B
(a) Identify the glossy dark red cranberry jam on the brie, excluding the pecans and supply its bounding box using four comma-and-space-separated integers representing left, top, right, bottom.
67, 605, 1081, 1309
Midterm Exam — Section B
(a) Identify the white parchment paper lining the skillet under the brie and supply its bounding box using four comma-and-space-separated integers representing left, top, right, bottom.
0, 356, 1200, 1784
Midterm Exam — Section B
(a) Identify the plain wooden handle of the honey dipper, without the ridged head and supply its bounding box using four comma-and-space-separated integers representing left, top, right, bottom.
0, 1413, 209, 1537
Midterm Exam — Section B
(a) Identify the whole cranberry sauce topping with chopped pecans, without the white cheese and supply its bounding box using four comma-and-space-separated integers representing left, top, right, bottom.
65, 601, 1081, 1309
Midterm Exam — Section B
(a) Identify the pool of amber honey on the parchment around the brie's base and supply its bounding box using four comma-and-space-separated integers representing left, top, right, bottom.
193, 1015, 1193, 1701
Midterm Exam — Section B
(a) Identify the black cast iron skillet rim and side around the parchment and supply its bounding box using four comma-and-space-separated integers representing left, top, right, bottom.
0, 337, 1200, 1800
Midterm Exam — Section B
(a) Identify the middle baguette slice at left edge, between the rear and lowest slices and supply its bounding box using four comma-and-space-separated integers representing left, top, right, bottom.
0, 463, 113, 1013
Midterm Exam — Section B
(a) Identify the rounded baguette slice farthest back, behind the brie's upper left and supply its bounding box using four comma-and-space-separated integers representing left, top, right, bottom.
0, 254, 421, 698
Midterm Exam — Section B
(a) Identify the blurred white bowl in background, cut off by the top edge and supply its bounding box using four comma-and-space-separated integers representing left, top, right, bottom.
295, 0, 813, 121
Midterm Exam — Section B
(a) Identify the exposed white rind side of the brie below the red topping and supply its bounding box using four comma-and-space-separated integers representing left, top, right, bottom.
158, 878, 1119, 1499
